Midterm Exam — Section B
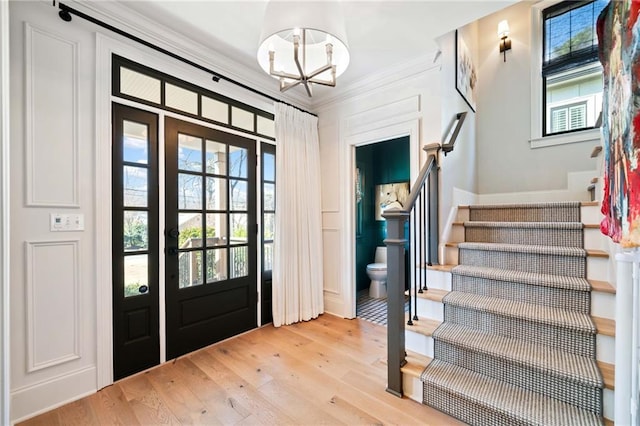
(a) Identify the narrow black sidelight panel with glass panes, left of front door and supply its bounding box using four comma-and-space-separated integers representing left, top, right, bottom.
112, 104, 160, 380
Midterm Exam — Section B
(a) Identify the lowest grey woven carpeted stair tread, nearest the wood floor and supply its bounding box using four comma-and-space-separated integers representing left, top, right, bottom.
420, 359, 602, 426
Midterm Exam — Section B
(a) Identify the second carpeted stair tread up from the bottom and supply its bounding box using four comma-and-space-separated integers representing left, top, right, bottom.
433, 323, 603, 388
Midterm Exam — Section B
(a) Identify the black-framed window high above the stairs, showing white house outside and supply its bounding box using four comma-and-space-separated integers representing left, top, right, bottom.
542, 0, 607, 136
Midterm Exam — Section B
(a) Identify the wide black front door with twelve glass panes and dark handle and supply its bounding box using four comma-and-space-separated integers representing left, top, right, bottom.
165, 118, 257, 359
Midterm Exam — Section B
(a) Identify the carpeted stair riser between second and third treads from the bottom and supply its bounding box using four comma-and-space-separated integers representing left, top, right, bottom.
444, 305, 596, 358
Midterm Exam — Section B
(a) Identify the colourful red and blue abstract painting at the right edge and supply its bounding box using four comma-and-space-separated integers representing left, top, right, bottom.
597, 1, 640, 247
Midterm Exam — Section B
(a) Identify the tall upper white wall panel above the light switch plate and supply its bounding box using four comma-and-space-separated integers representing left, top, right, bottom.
25, 24, 79, 207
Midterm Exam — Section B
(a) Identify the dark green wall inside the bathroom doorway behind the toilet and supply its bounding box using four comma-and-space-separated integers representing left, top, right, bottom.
356, 136, 410, 291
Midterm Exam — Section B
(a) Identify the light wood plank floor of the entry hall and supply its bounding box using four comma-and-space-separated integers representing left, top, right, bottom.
21, 314, 460, 426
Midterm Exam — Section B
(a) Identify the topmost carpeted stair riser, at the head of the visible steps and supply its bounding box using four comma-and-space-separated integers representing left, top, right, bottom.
469, 207, 580, 222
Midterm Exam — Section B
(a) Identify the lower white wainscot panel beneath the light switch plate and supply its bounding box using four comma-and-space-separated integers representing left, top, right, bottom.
25, 240, 80, 372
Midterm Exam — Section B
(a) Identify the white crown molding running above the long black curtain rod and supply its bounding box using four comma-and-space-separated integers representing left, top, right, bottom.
58, 0, 313, 110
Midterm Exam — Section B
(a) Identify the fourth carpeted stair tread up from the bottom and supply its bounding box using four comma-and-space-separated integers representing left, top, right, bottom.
451, 265, 591, 291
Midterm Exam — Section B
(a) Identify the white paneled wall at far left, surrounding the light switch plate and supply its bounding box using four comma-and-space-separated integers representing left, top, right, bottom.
9, 2, 96, 420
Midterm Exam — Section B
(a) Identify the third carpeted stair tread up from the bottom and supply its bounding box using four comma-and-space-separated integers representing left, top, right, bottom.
443, 291, 596, 334
